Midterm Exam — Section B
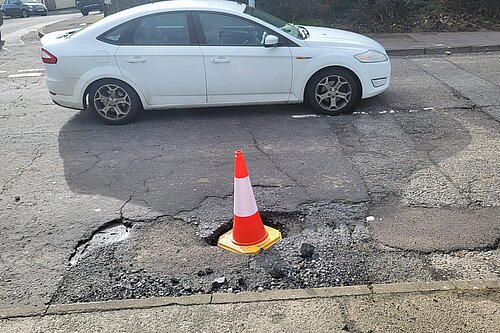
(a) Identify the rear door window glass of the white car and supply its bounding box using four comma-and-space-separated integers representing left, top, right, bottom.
125, 13, 190, 45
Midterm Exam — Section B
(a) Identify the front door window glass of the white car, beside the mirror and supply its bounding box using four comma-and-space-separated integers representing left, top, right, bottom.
199, 13, 269, 46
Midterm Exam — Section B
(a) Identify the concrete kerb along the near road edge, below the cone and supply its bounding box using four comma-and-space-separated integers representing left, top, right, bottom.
0, 279, 500, 319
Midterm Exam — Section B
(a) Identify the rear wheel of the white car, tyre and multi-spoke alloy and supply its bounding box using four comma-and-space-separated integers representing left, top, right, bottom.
88, 79, 142, 125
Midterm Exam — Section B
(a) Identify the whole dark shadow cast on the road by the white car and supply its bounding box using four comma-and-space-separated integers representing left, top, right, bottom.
59, 99, 471, 214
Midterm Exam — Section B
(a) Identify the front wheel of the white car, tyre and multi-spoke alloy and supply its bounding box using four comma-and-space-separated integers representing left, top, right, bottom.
305, 68, 361, 116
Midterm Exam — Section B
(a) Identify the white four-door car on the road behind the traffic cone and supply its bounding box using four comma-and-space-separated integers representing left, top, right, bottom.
42, 0, 391, 124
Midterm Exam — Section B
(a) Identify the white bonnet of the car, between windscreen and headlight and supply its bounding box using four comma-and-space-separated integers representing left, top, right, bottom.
304, 26, 386, 53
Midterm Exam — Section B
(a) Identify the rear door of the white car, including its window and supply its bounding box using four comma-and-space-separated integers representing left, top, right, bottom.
115, 12, 206, 108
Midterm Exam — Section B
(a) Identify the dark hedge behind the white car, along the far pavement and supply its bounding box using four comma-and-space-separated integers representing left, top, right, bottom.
111, 0, 500, 32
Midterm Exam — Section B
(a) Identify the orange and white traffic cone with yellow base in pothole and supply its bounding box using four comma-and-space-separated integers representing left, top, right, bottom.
217, 150, 281, 254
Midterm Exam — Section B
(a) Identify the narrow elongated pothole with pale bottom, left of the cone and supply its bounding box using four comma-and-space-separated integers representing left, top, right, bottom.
69, 221, 130, 267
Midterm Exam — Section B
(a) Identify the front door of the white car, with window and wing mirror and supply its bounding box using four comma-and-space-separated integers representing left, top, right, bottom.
194, 12, 292, 104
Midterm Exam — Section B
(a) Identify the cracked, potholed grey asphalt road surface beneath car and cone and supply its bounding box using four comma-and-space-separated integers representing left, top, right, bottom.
0, 27, 500, 307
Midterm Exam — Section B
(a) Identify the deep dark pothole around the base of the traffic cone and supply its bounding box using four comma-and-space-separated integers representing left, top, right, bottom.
202, 211, 304, 246
